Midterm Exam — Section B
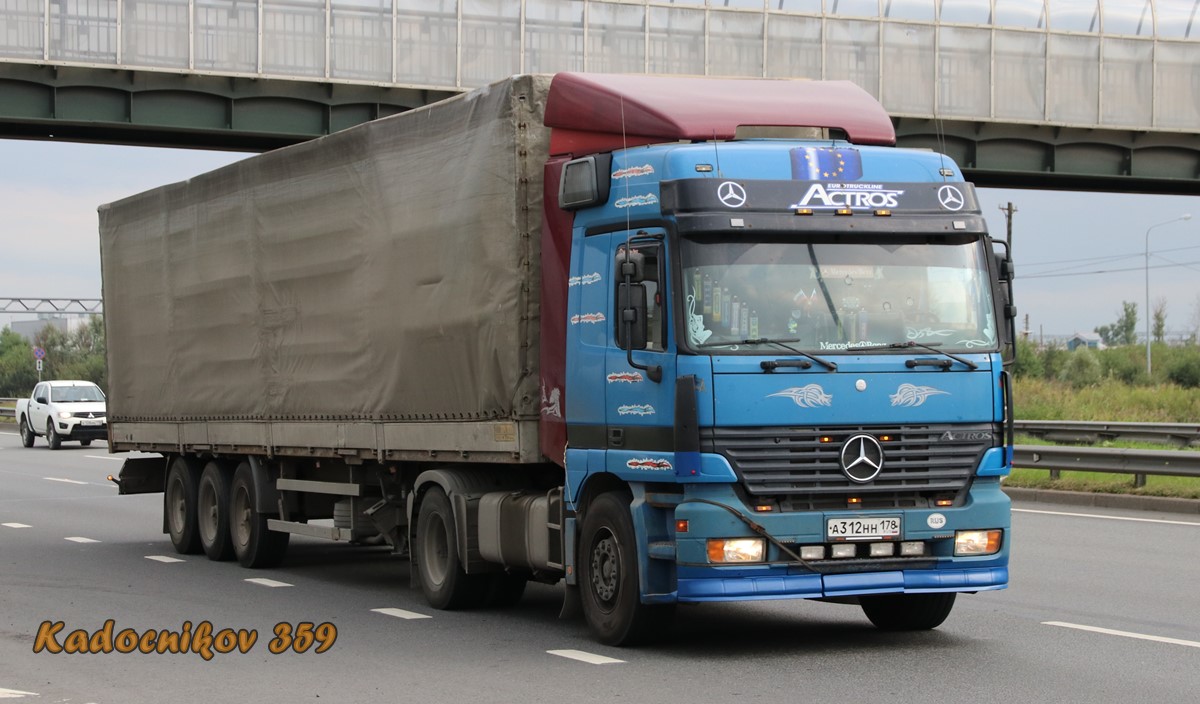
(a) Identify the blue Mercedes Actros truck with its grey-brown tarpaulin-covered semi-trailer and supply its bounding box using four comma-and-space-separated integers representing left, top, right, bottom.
108, 73, 1015, 644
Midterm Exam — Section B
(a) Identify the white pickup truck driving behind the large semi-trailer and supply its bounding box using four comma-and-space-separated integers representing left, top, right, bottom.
16, 381, 108, 450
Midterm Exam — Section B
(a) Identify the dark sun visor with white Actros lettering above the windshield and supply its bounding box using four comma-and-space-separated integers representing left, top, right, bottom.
661, 179, 979, 215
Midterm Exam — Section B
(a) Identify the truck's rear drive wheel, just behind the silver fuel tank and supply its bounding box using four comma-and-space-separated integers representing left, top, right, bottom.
413, 487, 490, 609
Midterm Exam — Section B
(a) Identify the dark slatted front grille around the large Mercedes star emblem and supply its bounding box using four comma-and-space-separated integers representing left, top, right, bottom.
708, 423, 1002, 511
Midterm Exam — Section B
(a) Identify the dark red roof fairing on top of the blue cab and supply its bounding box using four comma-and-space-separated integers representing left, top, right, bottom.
545, 73, 895, 155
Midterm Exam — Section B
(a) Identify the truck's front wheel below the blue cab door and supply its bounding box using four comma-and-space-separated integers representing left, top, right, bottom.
576, 492, 674, 645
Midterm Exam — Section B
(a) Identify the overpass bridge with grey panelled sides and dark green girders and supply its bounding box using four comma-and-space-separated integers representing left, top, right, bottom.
0, 0, 1200, 193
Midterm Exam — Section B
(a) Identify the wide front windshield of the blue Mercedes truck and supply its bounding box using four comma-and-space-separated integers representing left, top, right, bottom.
680, 237, 996, 354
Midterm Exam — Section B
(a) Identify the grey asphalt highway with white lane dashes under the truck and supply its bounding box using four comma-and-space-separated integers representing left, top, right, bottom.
0, 428, 1200, 704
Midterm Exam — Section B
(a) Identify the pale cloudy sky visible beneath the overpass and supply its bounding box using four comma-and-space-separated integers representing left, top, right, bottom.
0, 140, 1200, 339
